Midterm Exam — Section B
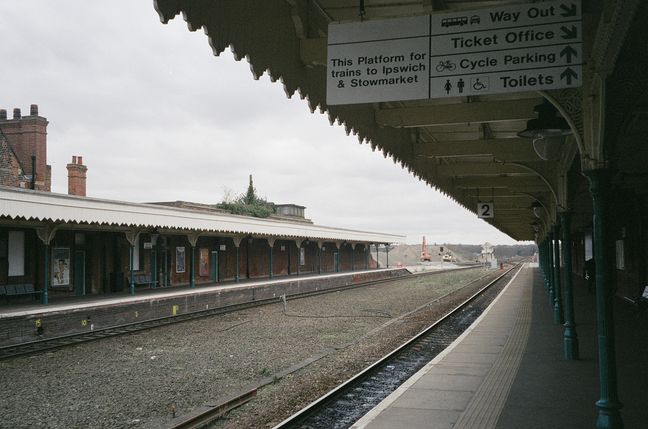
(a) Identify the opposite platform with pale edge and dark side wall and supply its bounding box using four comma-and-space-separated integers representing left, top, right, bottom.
0, 268, 409, 346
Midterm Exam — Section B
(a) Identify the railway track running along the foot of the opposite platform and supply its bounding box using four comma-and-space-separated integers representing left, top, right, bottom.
0, 266, 479, 360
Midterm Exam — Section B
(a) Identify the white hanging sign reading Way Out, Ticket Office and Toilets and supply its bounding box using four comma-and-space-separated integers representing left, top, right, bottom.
327, 1, 582, 105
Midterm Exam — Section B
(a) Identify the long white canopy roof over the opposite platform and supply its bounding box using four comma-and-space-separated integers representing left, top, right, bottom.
0, 187, 405, 244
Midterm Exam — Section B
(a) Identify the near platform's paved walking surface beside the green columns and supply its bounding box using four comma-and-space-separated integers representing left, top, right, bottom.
352, 265, 648, 429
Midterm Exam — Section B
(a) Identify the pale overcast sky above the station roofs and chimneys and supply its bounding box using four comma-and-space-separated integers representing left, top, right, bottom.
0, 0, 528, 244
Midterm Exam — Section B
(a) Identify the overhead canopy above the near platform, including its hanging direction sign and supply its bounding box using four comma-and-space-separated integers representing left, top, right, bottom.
155, 0, 648, 241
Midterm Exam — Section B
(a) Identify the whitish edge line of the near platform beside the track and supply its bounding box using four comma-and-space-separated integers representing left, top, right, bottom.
350, 263, 528, 429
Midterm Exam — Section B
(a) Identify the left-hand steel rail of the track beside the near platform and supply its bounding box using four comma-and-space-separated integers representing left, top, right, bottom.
273, 263, 522, 429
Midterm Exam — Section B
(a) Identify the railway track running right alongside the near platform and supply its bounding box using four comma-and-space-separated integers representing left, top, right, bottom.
274, 265, 521, 429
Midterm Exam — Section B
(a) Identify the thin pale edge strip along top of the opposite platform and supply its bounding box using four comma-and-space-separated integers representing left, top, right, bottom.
0, 267, 402, 319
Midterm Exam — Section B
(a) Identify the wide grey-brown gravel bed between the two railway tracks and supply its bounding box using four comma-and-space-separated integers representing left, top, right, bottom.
0, 269, 494, 428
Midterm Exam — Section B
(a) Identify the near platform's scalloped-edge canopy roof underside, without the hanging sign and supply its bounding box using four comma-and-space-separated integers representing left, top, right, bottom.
154, 0, 648, 241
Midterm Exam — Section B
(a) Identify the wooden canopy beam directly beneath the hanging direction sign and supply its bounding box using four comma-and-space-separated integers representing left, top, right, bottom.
375, 98, 541, 128
